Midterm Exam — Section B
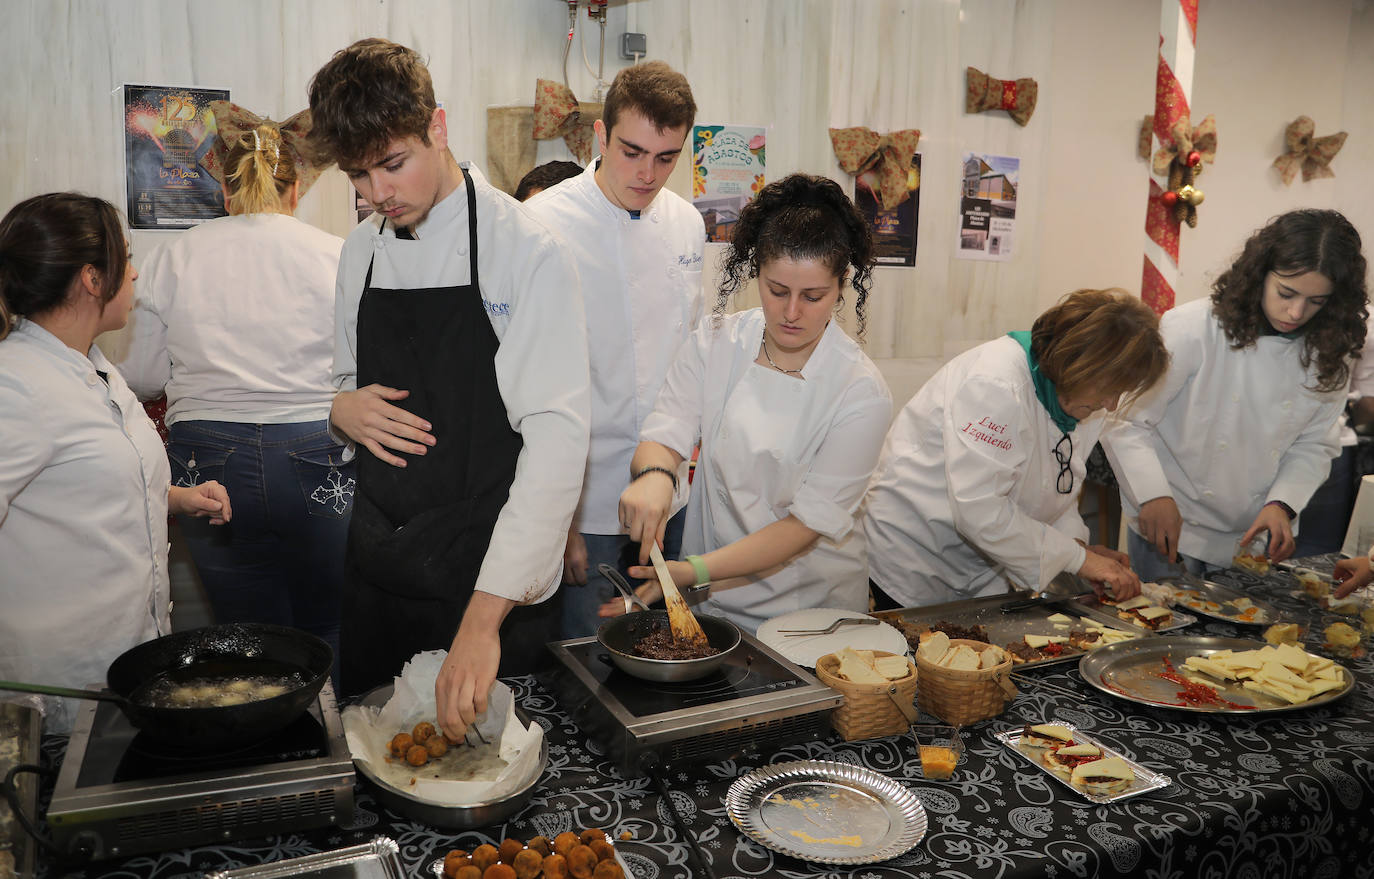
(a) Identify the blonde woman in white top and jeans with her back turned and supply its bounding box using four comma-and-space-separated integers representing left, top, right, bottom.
121, 100, 354, 681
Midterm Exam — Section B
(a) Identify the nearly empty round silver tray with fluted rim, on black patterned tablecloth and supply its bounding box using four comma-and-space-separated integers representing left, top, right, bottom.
725, 760, 926, 864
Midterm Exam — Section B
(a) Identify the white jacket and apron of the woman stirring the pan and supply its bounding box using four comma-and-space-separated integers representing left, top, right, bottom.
640, 308, 892, 630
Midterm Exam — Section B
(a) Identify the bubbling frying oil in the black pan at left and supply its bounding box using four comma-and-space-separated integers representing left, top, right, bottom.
132, 661, 309, 709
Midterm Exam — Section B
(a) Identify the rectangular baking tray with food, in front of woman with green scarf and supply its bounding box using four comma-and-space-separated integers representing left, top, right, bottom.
872, 593, 1153, 670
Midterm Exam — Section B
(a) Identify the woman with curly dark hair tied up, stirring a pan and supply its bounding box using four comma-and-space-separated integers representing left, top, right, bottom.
602, 174, 892, 630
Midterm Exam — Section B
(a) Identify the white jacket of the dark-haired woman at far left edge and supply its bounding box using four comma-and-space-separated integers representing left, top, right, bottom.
0, 320, 172, 732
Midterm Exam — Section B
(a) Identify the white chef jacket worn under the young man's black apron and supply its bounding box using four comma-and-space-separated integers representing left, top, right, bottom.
334, 168, 588, 604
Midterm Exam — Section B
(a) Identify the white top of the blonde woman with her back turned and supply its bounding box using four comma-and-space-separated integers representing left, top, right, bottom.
120, 213, 344, 424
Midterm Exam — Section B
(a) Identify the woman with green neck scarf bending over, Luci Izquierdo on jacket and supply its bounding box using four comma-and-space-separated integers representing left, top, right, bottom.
863, 290, 1168, 608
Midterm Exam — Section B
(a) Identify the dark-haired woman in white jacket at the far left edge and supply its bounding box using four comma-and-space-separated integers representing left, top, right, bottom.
0, 192, 231, 732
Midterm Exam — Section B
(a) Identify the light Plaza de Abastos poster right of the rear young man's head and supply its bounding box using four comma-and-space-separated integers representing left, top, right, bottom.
691, 125, 767, 242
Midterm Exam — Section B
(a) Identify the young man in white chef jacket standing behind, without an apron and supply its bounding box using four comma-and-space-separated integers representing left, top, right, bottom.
529, 62, 706, 637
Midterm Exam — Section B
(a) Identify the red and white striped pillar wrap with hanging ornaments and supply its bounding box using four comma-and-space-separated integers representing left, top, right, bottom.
1140, 0, 1198, 315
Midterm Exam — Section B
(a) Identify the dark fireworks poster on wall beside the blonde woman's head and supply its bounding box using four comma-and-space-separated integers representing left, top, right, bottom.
124, 85, 229, 231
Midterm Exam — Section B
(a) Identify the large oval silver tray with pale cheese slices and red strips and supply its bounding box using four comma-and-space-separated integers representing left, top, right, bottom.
1079, 635, 1355, 716
